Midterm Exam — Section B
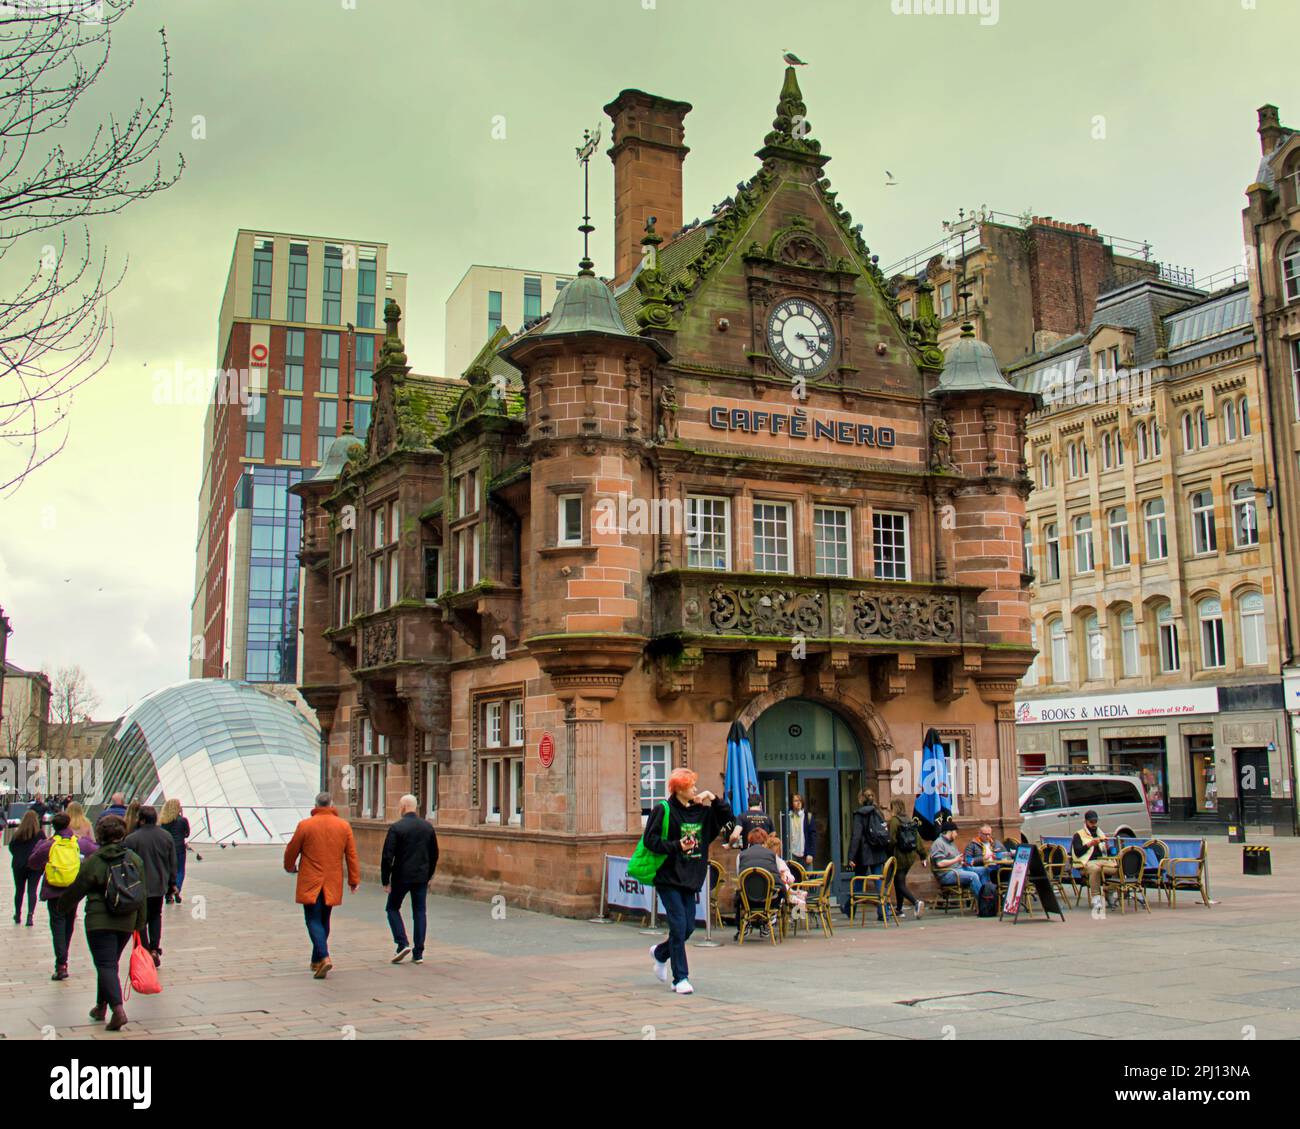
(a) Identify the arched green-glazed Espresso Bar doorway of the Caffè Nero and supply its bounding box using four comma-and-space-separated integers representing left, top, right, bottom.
750, 697, 866, 886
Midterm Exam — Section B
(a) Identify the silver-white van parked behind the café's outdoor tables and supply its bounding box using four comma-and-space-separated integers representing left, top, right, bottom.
1019, 771, 1151, 843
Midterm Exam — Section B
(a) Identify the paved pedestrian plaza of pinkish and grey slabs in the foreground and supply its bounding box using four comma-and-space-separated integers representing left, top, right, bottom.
0, 839, 1300, 1039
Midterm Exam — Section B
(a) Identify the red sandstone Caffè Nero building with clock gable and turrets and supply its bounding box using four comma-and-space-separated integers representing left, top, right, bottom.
294, 69, 1039, 914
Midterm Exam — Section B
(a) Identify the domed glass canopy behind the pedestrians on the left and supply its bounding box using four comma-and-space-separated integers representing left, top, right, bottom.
96, 679, 321, 843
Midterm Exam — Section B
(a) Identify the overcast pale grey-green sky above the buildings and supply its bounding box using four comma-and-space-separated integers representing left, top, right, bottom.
0, 0, 1300, 717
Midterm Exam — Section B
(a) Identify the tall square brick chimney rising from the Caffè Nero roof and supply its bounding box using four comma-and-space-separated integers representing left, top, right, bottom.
605, 90, 692, 284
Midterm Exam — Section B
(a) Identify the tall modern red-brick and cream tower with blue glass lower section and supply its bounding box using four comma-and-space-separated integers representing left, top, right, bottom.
190, 229, 407, 683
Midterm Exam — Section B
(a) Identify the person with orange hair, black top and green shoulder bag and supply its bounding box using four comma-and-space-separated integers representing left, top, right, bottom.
641, 769, 732, 995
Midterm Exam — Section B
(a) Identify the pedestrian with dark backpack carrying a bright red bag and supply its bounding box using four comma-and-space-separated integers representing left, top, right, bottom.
59, 816, 146, 1031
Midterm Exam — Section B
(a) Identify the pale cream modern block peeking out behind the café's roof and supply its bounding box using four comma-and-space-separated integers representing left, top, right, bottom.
444, 265, 573, 376
